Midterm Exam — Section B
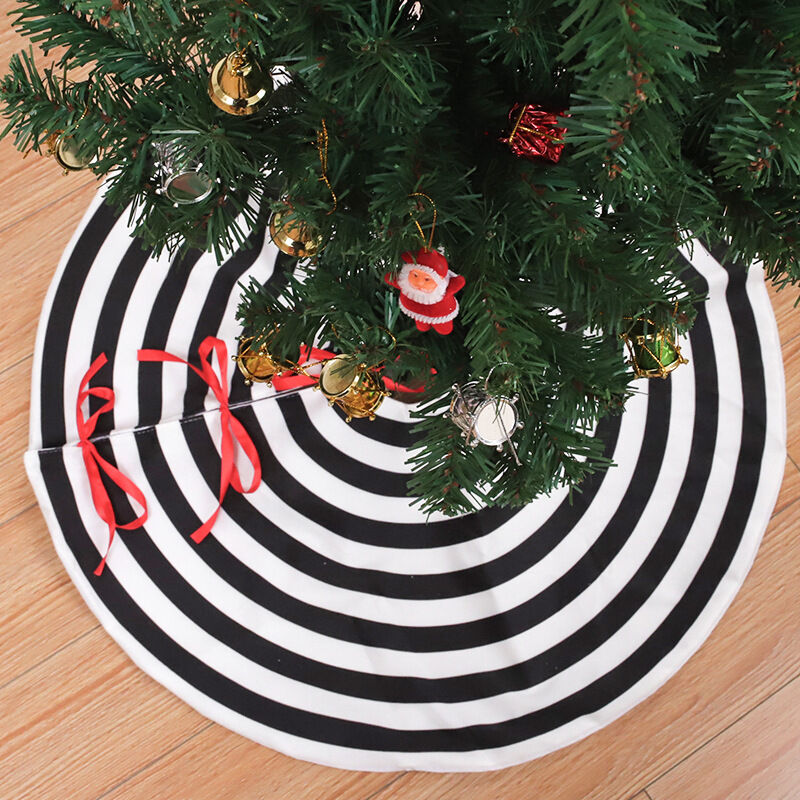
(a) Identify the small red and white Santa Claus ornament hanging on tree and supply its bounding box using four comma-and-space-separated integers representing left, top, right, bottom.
384, 247, 466, 335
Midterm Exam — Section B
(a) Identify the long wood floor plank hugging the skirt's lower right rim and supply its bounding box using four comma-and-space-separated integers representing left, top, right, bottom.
370, 503, 800, 800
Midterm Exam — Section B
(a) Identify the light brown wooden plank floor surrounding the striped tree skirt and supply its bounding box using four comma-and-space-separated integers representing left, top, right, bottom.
0, 17, 800, 800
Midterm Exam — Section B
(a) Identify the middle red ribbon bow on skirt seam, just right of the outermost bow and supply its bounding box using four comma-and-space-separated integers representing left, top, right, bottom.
138, 336, 261, 542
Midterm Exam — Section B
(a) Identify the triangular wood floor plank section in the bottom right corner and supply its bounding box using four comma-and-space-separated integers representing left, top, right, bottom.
647, 678, 800, 800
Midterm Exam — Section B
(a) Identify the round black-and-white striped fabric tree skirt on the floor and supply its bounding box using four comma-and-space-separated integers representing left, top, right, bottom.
26, 191, 786, 771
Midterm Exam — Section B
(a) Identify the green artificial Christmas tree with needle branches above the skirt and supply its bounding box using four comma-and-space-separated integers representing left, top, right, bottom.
2, 0, 800, 512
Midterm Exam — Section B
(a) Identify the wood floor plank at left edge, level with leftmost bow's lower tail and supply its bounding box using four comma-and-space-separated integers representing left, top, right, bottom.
0, 507, 99, 686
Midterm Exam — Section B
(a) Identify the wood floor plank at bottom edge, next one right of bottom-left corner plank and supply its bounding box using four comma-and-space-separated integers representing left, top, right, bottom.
103, 725, 396, 800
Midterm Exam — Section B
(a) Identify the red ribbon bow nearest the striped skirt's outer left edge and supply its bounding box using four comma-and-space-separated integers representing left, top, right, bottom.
75, 353, 147, 575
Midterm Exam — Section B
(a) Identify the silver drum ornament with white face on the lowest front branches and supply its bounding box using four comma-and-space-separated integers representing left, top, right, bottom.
447, 379, 522, 464
